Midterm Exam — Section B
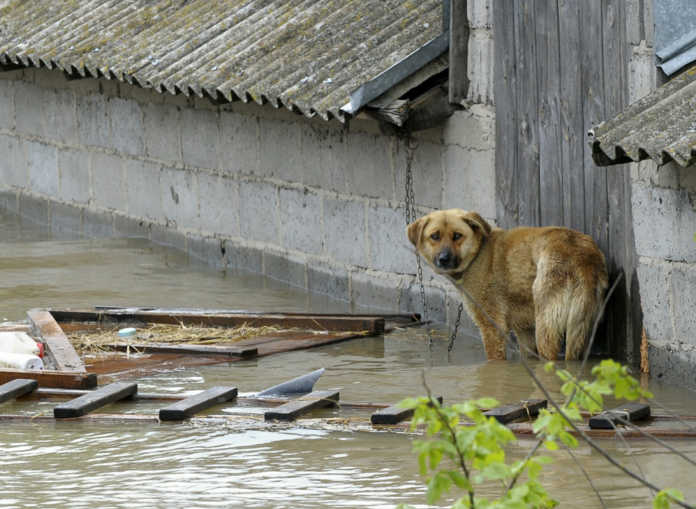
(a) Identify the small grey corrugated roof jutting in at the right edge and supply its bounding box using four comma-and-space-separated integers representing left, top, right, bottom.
590, 67, 696, 166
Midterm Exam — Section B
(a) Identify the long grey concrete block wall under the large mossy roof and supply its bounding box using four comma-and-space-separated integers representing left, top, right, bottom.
0, 69, 495, 338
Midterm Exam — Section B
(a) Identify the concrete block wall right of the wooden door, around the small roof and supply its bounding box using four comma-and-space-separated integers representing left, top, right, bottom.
624, 0, 696, 388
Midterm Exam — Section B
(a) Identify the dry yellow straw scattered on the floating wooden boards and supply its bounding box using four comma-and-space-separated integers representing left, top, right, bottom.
68, 323, 297, 357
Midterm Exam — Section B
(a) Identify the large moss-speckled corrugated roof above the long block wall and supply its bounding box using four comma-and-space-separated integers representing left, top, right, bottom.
0, 0, 442, 120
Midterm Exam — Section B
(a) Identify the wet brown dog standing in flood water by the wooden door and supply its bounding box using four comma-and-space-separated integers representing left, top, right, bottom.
407, 209, 608, 359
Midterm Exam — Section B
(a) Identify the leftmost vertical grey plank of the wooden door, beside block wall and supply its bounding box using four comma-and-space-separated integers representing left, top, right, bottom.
493, 2, 519, 228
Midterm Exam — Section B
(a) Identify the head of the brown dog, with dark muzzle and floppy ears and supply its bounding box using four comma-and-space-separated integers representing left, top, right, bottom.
406, 209, 491, 277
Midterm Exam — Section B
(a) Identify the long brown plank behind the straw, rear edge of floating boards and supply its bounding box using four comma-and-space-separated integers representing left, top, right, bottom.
51, 309, 384, 334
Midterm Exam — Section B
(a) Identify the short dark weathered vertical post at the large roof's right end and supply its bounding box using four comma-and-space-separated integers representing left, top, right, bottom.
448, 0, 469, 104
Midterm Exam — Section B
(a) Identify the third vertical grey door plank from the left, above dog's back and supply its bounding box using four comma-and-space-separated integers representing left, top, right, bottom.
533, 0, 564, 226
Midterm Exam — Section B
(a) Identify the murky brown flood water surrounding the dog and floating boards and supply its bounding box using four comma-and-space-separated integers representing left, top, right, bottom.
0, 211, 696, 508
